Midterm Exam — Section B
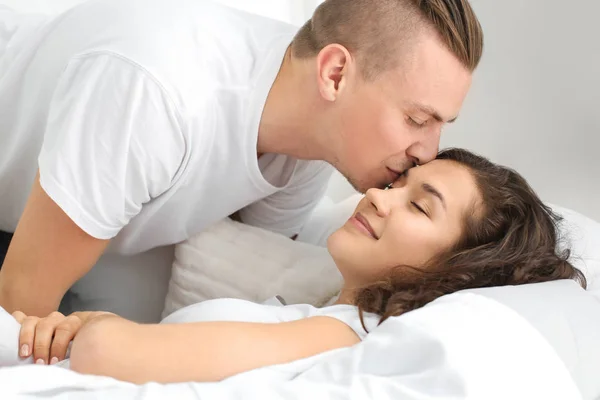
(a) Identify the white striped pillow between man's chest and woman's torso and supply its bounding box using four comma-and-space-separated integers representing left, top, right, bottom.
163, 218, 342, 318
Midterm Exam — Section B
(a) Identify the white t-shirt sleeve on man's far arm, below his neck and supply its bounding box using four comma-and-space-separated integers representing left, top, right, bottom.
240, 161, 333, 237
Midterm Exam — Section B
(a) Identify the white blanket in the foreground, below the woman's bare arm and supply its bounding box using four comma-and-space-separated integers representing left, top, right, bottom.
0, 293, 581, 400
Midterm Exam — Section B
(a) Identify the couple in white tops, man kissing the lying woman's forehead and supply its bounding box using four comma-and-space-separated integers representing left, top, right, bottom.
0, 0, 585, 388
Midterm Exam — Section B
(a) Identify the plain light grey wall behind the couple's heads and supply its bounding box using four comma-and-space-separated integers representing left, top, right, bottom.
329, 0, 600, 221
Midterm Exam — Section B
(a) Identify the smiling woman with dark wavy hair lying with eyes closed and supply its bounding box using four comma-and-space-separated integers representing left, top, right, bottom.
14, 149, 586, 383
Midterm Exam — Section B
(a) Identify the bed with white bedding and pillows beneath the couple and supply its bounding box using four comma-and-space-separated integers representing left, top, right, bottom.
0, 198, 600, 400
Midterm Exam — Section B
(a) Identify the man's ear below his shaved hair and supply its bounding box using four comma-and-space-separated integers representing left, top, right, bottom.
317, 44, 353, 102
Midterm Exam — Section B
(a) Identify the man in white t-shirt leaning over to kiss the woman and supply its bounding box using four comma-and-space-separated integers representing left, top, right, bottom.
0, 0, 483, 316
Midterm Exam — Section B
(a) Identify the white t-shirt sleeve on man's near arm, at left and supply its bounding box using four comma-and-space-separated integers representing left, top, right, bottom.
38, 53, 185, 239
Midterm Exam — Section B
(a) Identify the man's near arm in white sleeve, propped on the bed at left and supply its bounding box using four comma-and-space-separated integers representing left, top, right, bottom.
0, 52, 186, 317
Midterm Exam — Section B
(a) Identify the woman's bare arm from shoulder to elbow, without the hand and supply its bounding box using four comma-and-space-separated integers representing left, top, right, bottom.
71, 316, 360, 384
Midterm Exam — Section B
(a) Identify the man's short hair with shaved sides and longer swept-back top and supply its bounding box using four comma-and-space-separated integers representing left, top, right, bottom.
292, 0, 483, 79
